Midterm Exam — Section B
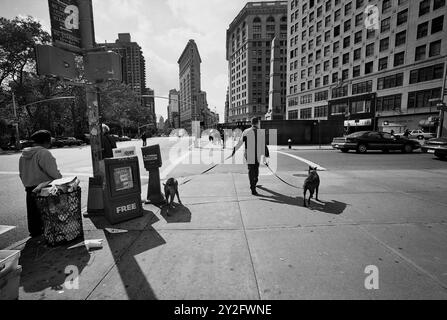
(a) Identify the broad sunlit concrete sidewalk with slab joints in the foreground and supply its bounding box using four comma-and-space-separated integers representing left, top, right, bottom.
9, 170, 447, 300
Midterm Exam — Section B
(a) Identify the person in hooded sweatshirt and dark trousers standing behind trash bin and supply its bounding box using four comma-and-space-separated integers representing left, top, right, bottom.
19, 130, 62, 238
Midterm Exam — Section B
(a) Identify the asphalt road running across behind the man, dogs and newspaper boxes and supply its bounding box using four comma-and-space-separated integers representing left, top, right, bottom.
0, 138, 447, 248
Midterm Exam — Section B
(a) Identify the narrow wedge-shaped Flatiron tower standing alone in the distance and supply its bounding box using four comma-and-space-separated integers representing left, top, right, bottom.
178, 40, 206, 131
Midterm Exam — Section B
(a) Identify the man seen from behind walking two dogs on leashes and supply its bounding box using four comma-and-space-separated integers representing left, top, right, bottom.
232, 118, 270, 196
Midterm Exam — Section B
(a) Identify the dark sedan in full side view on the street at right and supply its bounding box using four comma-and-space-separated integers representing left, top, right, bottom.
332, 131, 421, 153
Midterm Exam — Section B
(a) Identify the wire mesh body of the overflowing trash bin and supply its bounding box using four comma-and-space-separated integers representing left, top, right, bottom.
36, 188, 84, 246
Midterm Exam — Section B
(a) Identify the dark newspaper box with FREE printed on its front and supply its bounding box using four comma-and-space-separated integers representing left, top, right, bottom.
103, 157, 143, 224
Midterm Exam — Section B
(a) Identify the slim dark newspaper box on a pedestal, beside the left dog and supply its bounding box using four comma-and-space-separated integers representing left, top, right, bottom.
141, 145, 165, 205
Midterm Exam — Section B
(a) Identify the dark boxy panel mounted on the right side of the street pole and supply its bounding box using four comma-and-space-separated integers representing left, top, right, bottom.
85, 51, 123, 83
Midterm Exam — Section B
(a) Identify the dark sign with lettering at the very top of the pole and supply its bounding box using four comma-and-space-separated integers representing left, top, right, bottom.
48, 0, 82, 53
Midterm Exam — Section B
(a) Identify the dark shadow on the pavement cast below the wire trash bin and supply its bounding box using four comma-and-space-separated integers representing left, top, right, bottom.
17, 238, 90, 298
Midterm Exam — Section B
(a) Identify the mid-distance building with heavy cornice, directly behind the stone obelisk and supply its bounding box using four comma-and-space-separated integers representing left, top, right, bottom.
227, 1, 287, 122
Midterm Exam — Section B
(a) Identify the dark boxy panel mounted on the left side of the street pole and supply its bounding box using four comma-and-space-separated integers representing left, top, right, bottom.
36, 45, 77, 80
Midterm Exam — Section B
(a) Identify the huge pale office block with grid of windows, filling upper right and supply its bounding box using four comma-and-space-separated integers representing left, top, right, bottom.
287, 0, 447, 132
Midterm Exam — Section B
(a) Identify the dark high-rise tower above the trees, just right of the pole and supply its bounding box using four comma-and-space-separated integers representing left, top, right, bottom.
98, 33, 146, 96
